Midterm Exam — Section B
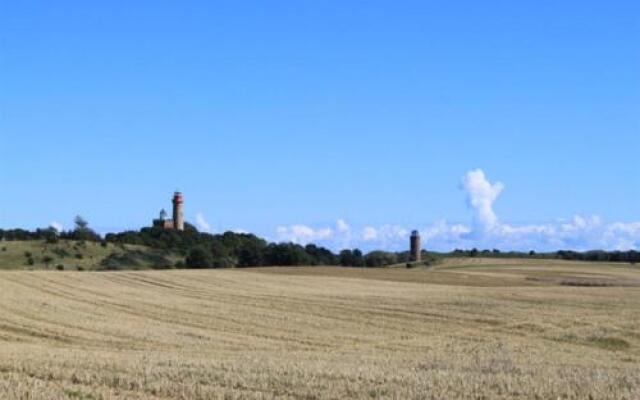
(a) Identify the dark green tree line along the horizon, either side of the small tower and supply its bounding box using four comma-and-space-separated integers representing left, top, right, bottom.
0, 216, 640, 268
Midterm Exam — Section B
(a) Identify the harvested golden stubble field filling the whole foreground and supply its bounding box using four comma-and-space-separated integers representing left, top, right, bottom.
0, 260, 640, 399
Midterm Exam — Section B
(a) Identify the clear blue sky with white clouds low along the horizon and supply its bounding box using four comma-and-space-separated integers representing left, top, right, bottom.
0, 0, 640, 251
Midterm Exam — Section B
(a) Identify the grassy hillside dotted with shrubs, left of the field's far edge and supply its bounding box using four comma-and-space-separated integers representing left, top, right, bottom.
0, 240, 182, 270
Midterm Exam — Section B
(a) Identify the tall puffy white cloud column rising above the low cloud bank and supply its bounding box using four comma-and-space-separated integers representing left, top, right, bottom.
462, 169, 504, 230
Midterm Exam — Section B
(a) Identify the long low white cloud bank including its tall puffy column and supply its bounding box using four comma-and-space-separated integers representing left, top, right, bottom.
266, 169, 640, 251
